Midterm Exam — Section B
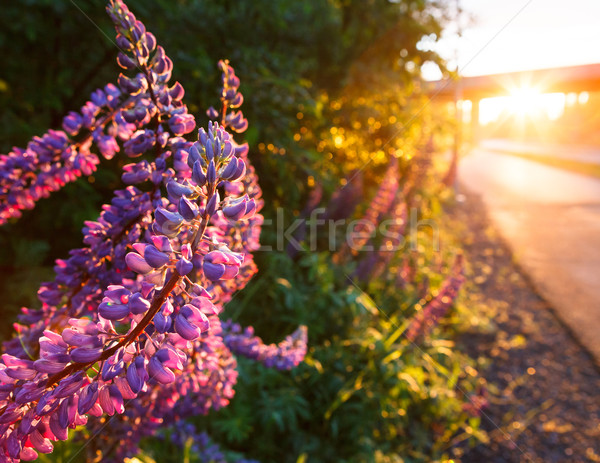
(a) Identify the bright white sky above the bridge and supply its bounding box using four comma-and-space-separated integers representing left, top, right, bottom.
424, 0, 600, 79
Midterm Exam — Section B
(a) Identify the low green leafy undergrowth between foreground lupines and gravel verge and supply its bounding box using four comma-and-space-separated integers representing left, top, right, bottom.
199, 199, 485, 462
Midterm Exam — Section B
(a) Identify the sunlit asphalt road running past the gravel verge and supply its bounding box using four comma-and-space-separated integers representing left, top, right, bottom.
459, 148, 600, 364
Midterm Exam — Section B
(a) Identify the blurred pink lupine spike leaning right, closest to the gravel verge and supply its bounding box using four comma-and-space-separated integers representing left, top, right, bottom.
406, 255, 465, 342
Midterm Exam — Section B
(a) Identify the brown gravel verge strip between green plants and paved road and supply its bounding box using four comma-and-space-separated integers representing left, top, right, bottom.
448, 192, 600, 463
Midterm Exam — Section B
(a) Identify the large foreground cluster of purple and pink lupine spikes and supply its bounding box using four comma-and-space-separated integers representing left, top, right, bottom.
0, 0, 306, 462
